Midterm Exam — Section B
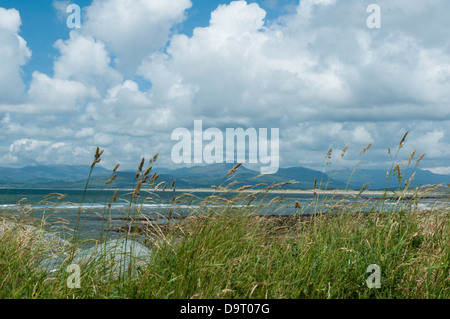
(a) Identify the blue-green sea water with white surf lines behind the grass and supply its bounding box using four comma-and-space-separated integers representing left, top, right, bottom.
0, 189, 438, 244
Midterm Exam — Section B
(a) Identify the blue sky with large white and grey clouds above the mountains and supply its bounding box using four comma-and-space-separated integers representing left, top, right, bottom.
0, 0, 450, 174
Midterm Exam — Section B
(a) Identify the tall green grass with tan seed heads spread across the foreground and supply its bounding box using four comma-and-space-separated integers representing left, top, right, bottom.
0, 135, 450, 299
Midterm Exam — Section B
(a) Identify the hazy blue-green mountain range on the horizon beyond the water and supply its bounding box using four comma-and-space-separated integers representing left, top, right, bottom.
0, 163, 450, 190
